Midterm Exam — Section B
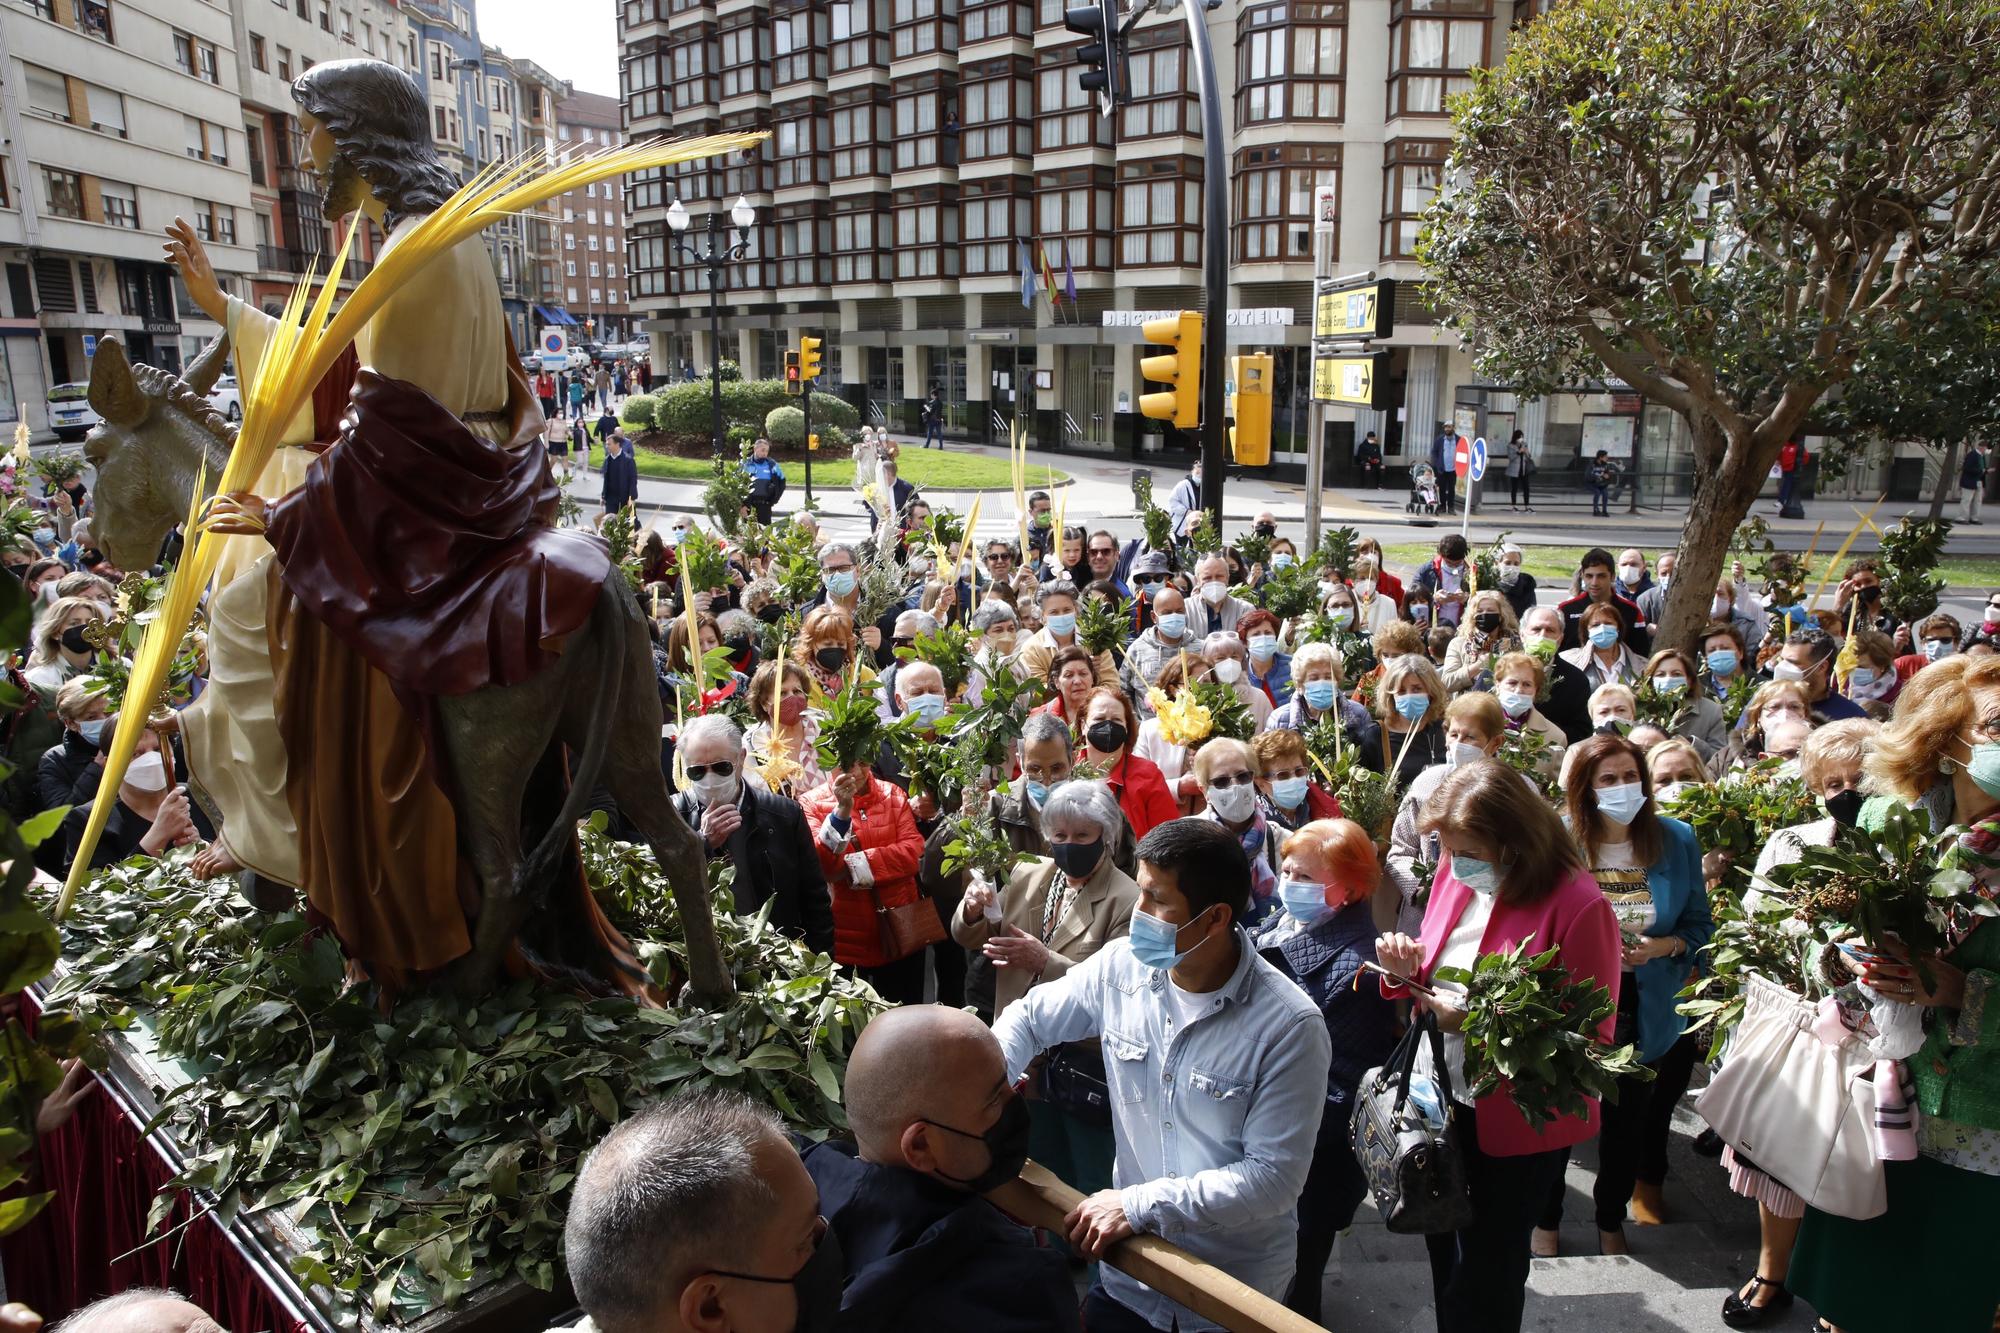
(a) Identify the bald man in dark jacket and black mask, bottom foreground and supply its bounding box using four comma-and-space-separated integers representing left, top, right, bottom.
806, 1005, 1078, 1333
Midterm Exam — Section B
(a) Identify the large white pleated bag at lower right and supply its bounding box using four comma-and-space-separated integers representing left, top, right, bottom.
1694, 964, 1888, 1221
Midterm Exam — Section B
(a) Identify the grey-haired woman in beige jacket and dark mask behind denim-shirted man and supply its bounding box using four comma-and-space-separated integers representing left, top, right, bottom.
952, 781, 1138, 1195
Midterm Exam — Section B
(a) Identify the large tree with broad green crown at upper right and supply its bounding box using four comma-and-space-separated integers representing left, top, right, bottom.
1418, 0, 2000, 642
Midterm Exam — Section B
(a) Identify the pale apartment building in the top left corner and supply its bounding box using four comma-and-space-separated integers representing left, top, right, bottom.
0, 0, 256, 430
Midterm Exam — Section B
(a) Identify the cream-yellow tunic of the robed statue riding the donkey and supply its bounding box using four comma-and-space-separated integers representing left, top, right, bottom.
180, 218, 508, 885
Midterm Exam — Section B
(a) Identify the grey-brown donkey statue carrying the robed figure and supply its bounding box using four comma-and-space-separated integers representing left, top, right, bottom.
84, 338, 734, 1007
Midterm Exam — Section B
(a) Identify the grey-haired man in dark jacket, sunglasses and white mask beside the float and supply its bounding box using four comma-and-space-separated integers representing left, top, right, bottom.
674, 713, 834, 953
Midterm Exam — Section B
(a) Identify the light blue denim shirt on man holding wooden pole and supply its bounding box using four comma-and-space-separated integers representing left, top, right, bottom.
994, 929, 1332, 1333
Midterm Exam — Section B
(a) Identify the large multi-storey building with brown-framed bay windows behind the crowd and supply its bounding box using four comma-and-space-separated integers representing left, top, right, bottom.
620, 0, 1616, 466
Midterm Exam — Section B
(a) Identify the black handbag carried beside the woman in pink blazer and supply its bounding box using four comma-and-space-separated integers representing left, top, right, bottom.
1348, 1011, 1472, 1235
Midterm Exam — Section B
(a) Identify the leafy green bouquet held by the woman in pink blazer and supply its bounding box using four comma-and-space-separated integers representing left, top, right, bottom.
1438, 941, 1654, 1129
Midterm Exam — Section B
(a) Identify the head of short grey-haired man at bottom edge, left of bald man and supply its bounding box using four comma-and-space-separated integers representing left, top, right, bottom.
564, 1091, 846, 1333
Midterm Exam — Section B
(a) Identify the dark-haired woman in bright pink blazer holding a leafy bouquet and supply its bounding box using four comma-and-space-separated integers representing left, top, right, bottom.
1376, 759, 1620, 1333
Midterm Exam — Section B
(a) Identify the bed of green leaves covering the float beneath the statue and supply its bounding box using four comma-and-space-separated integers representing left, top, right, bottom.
37, 836, 880, 1323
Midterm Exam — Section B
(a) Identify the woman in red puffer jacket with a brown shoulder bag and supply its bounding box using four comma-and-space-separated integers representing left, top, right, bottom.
798, 763, 926, 1005
